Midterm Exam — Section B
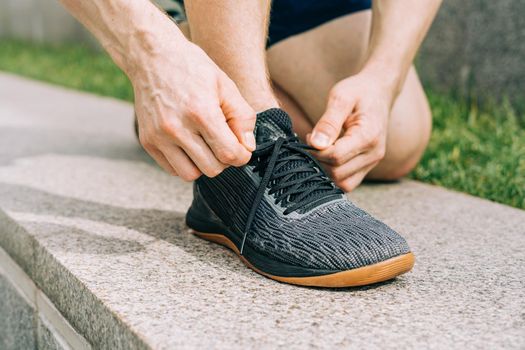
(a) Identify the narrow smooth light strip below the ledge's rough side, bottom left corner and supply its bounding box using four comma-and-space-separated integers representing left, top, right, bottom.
0, 247, 91, 349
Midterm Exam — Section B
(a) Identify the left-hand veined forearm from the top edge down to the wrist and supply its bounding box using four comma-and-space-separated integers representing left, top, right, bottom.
60, 0, 186, 76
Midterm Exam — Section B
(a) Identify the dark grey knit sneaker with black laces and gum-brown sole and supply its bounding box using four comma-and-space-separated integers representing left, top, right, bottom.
186, 108, 414, 287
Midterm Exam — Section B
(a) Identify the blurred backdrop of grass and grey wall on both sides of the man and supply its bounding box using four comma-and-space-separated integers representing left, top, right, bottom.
0, 0, 525, 208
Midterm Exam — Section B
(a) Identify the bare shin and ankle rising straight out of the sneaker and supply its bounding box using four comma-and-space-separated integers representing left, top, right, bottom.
185, 0, 278, 112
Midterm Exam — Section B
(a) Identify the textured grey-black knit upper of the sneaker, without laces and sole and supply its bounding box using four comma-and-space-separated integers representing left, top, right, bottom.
197, 109, 410, 271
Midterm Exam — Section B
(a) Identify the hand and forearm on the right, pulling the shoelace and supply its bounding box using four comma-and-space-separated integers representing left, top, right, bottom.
300, 0, 441, 191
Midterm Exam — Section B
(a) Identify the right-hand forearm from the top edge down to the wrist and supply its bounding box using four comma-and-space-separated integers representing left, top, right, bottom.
362, 0, 441, 97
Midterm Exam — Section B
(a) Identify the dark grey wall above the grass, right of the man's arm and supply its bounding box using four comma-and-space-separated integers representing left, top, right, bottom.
418, 0, 525, 104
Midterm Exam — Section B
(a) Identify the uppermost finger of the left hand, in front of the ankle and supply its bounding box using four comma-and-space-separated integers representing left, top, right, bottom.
219, 77, 256, 152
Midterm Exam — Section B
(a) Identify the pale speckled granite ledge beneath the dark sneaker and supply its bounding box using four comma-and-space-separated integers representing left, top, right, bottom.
0, 75, 525, 349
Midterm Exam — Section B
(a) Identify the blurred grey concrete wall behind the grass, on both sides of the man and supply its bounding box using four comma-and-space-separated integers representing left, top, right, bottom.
0, 0, 525, 103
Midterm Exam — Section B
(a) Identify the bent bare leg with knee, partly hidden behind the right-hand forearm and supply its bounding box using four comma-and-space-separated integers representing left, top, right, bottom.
267, 11, 431, 180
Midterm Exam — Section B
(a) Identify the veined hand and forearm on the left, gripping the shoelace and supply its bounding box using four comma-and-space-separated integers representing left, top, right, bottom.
56, 0, 255, 181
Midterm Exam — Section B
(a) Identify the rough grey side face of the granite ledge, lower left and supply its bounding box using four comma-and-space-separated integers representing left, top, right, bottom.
0, 208, 151, 349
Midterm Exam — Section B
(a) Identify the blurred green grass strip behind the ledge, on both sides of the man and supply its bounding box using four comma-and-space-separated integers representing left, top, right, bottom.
0, 40, 525, 209
